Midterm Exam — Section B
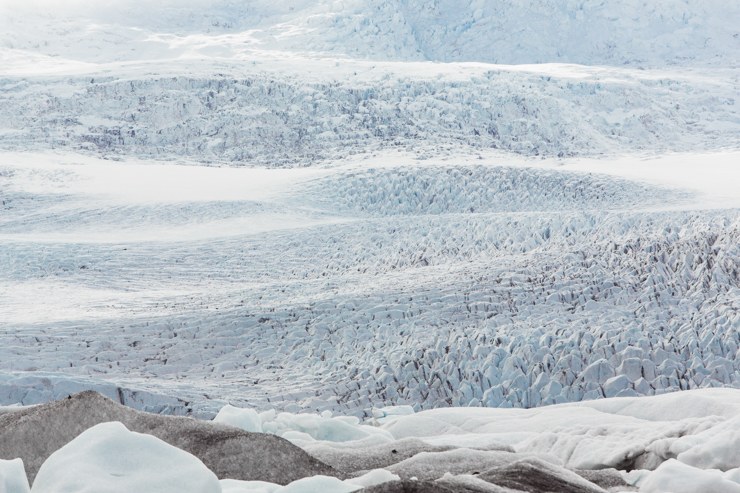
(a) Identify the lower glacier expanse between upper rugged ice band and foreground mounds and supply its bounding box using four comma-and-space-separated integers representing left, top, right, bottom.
0, 147, 740, 417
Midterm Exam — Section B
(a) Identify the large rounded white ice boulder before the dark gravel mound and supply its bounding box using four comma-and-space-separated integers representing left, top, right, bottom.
32, 422, 221, 493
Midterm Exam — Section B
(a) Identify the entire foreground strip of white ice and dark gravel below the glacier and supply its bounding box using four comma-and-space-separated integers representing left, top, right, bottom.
13, 389, 740, 493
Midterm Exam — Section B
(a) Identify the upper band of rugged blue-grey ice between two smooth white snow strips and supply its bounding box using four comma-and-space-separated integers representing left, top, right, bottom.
0, 62, 740, 166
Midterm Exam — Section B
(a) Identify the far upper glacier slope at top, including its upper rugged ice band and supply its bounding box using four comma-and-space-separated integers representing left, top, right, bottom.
0, 0, 740, 166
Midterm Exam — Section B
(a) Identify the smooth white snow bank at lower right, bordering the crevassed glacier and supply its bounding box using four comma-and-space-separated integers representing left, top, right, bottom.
376, 389, 740, 470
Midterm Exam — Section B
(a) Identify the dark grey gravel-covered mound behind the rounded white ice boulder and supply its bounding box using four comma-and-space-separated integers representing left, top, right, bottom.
0, 391, 337, 485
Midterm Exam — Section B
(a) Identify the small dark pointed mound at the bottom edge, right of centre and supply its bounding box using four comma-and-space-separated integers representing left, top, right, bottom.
479, 457, 606, 493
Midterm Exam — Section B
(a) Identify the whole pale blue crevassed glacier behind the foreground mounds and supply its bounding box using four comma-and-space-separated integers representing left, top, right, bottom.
0, 0, 740, 418
